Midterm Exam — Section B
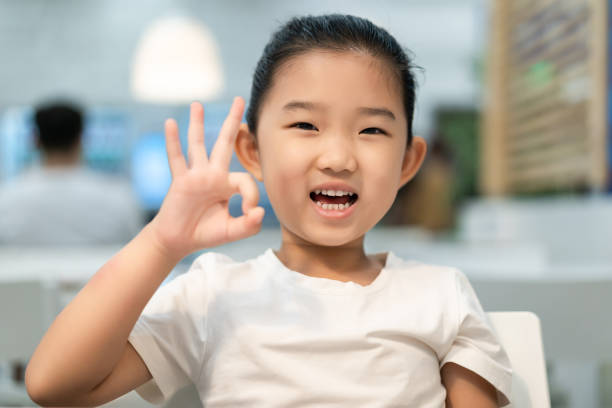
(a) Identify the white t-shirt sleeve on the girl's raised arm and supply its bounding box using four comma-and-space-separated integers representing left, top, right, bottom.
128, 255, 207, 404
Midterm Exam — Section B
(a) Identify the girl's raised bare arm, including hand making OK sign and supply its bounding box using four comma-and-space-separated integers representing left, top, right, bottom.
26, 98, 263, 406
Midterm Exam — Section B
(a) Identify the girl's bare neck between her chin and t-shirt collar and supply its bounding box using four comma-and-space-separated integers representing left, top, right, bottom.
276, 228, 384, 284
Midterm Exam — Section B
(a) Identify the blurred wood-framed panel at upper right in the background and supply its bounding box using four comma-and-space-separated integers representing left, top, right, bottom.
481, 0, 608, 195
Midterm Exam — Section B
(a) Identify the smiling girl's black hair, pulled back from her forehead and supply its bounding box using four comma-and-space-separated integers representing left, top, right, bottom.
246, 14, 416, 146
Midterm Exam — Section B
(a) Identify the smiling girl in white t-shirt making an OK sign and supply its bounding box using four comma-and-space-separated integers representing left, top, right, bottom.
26, 15, 511, 408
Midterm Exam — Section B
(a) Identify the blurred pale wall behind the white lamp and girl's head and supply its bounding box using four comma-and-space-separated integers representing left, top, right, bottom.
0, 0, 486, 137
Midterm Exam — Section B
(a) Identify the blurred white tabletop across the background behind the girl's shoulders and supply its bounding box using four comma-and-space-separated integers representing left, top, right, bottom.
0, 228, 612, 282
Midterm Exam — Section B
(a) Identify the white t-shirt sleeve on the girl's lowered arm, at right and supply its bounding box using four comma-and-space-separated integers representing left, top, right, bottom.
440, 270, 512, 406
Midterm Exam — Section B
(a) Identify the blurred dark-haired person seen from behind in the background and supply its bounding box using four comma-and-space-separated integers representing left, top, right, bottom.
0, 101, 144, 245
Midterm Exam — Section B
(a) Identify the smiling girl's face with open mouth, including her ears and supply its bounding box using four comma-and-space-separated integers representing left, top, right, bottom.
237, 51, 426, 246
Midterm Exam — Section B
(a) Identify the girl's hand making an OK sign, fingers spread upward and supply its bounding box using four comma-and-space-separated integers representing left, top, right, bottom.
149, 97, 264, 258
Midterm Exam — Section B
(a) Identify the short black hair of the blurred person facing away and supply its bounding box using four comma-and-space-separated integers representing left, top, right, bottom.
34, 101, 83, 152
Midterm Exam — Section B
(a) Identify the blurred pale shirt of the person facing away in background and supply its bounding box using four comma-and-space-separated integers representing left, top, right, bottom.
0, 167, 144, 245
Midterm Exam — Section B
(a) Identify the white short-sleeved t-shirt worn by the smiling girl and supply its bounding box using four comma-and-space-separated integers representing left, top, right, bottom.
129, 249, 512, 408
